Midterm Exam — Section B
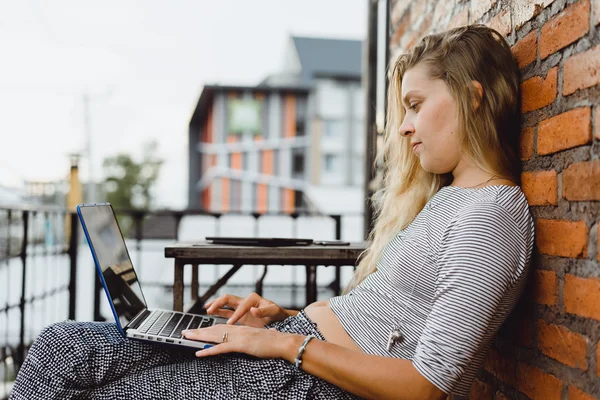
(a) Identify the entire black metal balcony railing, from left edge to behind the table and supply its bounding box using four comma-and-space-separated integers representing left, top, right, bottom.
0, 207, 361, 399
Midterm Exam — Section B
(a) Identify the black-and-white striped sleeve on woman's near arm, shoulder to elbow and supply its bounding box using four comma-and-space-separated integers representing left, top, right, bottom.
413, 203, 523, 393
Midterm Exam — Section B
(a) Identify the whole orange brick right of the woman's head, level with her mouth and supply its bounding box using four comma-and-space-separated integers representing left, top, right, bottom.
537, 107, 592, 155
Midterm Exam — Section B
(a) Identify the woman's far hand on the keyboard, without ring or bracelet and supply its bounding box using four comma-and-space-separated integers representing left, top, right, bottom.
205, 293, 291, 328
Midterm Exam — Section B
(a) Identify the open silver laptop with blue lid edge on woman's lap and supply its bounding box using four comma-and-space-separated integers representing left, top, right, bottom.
77, 203, 227, 349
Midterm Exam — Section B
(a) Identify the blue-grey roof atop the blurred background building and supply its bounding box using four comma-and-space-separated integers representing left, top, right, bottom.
292, 36, 363, 85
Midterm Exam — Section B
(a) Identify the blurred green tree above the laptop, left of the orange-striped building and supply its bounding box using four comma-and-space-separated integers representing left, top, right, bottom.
103, 140, 163, 210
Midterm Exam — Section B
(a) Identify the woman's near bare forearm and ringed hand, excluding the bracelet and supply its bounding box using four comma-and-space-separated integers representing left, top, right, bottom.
182, 324, 446, 400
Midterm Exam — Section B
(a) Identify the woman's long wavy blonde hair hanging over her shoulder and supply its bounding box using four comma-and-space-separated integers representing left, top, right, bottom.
344, 25, 521, 293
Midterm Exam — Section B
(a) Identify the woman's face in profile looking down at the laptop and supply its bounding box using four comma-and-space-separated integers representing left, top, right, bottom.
399, 65, 461, 174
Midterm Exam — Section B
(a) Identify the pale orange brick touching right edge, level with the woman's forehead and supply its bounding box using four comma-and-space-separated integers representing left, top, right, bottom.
563, 46, 600, 96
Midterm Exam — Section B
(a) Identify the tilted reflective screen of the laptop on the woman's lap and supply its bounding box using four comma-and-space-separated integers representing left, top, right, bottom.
79, 204, 146, 327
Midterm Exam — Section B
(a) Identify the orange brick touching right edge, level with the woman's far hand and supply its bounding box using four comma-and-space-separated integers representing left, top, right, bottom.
565, 274, 600, 321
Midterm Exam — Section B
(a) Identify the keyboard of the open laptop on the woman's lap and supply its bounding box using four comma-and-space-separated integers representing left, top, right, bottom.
138, 311, 214, 339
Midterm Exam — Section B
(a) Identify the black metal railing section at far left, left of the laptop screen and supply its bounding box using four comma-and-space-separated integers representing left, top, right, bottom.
0, 208, 78, 398
